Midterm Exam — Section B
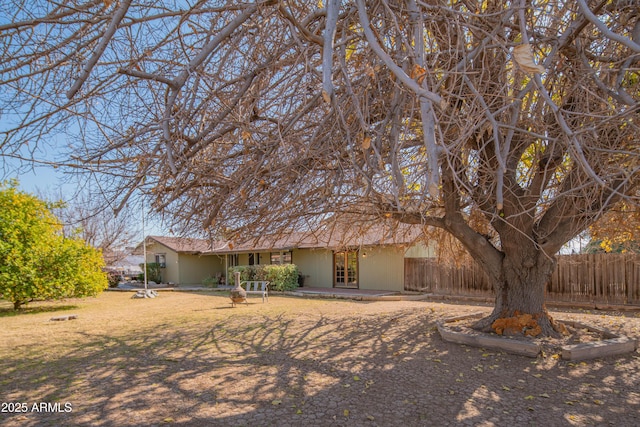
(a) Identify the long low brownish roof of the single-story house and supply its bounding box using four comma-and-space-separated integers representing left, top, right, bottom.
138, 224, 422, 255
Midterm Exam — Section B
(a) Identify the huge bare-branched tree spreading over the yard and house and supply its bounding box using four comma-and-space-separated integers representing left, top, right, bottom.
0, 0, 640, 334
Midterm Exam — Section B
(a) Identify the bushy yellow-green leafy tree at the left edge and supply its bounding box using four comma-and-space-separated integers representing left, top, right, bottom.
0, 180, 108, 310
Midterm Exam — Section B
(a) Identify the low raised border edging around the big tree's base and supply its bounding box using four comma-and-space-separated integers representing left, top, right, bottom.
437, 313, 637, 361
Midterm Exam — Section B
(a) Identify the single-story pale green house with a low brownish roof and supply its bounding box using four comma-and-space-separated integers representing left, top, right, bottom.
138, 227, 435, 291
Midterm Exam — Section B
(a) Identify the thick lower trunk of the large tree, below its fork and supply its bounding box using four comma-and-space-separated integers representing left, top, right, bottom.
475, 249, 559, 336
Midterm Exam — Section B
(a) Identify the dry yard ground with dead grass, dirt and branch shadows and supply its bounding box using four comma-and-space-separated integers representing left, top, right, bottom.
0, 292, 640, 427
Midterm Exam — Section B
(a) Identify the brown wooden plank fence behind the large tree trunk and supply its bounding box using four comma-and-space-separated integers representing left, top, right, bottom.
404, 254, 640, 305
